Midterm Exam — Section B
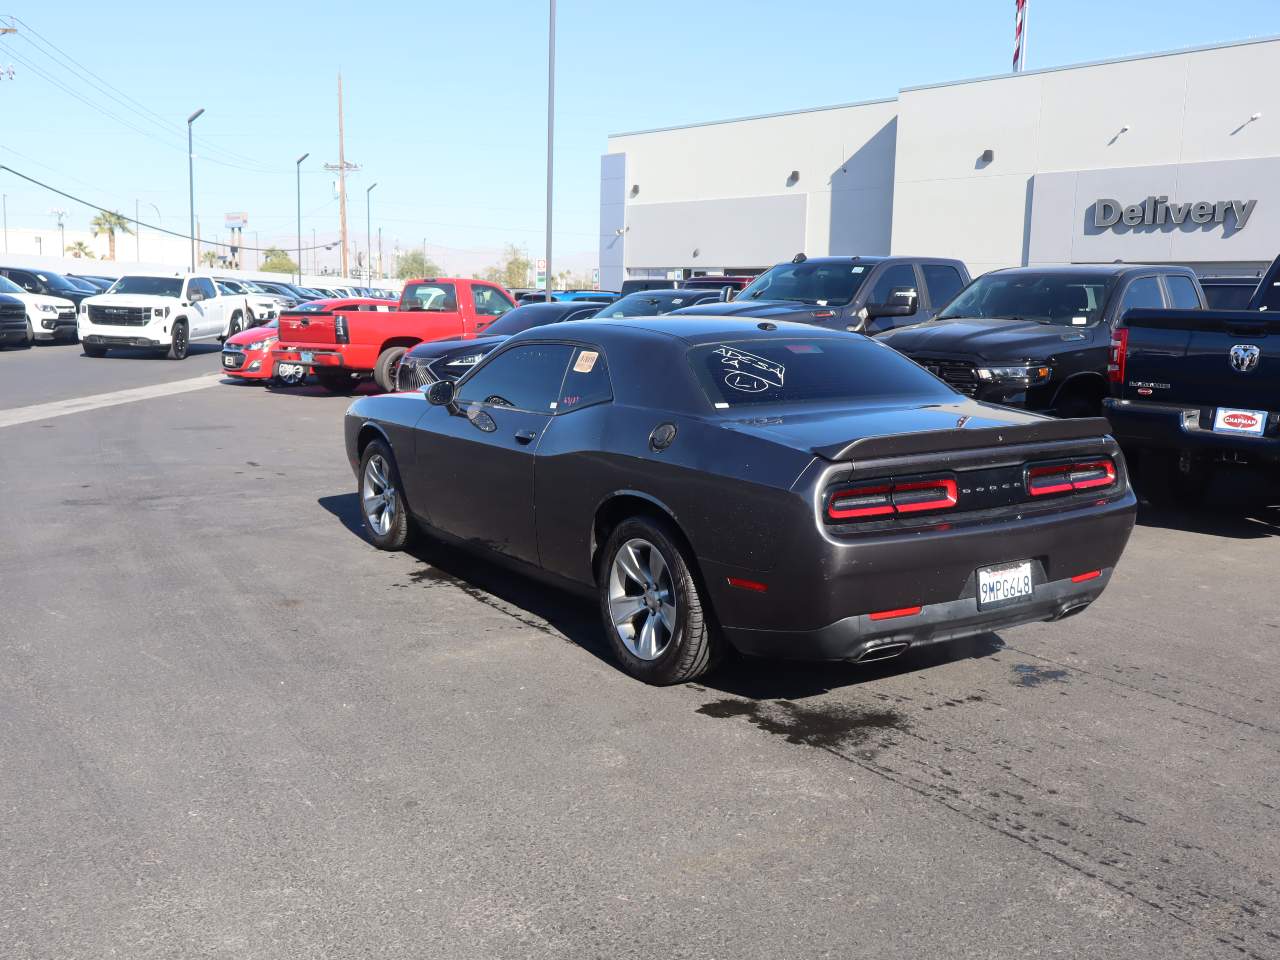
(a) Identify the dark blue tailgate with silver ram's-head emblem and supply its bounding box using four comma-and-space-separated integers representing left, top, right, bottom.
1121, 310, 1280, 410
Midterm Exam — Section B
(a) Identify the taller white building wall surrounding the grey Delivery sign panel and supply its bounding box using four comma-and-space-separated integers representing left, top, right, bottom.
892, 40, 1280, 274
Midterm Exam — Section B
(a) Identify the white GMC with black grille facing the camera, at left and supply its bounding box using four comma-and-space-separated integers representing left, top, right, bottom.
77, 274, 244, 360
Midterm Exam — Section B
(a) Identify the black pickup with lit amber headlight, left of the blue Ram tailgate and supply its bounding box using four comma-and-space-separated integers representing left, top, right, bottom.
879, 264, 1204, 417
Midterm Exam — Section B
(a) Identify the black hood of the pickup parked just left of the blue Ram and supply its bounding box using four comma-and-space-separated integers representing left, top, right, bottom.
876, 319, 1091, 362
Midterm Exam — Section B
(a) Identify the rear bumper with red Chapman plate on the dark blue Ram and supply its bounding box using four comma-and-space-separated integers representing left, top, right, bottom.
1102, 398, 1280, 462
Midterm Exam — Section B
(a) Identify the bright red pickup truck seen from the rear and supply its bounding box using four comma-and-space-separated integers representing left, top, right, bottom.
271, 276, 516, 392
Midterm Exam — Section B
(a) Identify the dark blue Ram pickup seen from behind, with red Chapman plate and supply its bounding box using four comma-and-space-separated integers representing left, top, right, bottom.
1105, 259, 1280, 493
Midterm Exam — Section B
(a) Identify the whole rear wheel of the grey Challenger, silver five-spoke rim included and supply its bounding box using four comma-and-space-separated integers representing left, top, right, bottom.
599, 517, 718, 685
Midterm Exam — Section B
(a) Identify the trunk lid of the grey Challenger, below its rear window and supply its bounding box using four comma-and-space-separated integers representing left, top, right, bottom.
726, 394, 1047, 453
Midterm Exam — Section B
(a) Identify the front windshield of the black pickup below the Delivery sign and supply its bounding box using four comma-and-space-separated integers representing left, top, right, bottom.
937, 273, 1116, 326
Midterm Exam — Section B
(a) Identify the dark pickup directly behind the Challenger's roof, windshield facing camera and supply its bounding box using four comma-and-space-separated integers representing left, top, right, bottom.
670, 253, 969, 334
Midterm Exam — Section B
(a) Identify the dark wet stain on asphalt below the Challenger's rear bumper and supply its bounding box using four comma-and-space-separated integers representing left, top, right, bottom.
698, 698, 910, 750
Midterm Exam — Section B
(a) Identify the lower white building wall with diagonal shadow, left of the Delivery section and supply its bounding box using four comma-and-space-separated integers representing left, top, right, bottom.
602, 101, 896, 270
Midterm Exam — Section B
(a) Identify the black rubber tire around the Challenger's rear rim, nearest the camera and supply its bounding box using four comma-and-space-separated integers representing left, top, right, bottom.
598, 516, 722, 686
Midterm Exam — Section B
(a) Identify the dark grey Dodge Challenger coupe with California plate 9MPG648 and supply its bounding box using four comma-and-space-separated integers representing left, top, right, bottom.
346, 316, 1135, 684
